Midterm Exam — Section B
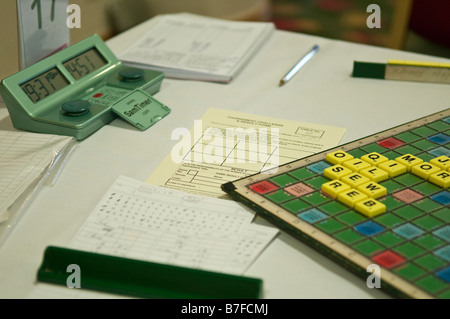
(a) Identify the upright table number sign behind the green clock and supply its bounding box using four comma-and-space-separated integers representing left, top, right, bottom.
17, 0, 70, 69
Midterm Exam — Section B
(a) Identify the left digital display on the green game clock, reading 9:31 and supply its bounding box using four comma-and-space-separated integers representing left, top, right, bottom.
20, 67, 69, 103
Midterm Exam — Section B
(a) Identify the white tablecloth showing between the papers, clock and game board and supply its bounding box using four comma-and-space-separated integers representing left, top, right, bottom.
0, 18, 450, 299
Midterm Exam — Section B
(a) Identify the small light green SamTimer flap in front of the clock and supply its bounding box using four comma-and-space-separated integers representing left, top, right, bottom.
112, 90, 170, 131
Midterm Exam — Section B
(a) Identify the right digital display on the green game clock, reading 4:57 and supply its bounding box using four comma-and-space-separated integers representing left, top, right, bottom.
63, 48, 107, 80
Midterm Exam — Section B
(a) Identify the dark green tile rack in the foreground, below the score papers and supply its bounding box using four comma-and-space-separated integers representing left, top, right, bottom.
37, 246, 263, 299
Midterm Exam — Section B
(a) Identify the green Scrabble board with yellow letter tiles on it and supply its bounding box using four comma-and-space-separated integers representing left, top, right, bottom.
222, 109, 450, 299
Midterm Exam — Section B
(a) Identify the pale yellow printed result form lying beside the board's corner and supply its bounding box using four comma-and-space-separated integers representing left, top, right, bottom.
146, 108, 346, 198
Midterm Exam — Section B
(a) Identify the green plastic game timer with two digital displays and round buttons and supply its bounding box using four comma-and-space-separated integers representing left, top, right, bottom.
0, 34, 164, 140
